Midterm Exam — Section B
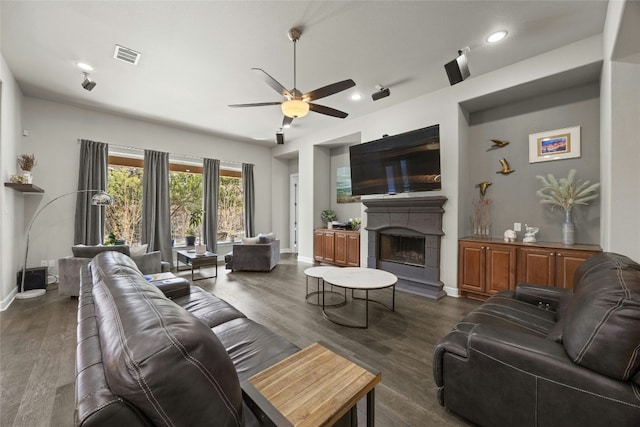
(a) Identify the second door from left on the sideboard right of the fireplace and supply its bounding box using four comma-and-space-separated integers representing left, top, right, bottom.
484, 245, 516, 294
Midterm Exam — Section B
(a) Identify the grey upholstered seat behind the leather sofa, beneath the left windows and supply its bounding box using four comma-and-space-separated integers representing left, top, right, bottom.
58, 245, 171, 297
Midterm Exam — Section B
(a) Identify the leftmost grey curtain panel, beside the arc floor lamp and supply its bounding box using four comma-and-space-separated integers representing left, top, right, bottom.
73, 139, 109, 245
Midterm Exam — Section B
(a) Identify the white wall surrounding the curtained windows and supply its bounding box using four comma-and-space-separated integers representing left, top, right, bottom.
23, 97, 281, 276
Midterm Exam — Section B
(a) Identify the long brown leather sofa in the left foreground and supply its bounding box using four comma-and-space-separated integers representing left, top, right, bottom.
75, 252, 308, 427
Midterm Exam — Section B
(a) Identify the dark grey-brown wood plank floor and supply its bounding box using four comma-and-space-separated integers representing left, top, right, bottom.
0, 256, 478, 427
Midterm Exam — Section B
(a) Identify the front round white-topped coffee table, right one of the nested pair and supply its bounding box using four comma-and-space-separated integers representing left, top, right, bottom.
322, 267, 398, 328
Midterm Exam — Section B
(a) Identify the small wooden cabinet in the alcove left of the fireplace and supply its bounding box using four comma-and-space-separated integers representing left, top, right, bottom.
313, 228, 360, 267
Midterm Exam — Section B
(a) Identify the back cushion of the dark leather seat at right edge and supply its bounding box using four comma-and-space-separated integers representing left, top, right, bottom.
562, 253, 640, 380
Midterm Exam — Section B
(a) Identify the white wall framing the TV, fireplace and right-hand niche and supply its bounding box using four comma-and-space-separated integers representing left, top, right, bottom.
273, 36, 602, 295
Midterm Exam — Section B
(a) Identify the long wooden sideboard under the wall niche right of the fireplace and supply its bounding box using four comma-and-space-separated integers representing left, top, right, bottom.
458, 238, 601, 299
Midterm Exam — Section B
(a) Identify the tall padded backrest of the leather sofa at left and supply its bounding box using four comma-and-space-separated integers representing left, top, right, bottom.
91, 252, 243, 426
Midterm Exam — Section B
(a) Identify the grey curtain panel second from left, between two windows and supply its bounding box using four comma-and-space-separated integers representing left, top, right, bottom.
142, 150, 173, 266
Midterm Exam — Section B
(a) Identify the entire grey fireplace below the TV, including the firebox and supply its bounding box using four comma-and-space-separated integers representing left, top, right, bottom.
362, 197, 447, 299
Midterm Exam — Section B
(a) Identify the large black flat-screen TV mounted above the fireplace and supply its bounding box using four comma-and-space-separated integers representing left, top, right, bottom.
349, 125, 441, 196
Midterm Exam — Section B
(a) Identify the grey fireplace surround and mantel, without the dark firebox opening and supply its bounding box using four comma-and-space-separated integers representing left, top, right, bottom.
362, 196, 447, 299
